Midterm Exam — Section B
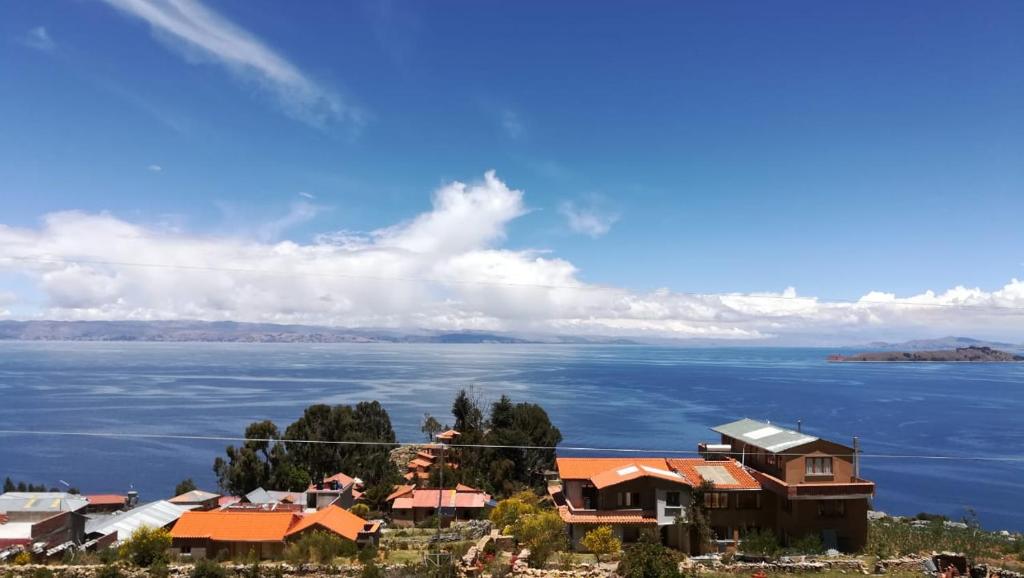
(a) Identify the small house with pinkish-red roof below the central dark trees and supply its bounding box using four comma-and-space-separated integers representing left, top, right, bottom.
387, 484, 494, 528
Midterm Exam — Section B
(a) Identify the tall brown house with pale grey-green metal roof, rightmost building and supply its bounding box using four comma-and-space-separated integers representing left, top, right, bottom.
699, 419, 874, 551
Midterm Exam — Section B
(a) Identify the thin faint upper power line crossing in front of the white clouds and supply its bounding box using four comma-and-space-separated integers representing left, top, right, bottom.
0, 256, 1024, 312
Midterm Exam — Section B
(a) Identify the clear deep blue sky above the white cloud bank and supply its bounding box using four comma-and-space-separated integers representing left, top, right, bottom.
0, 0, 1024, 340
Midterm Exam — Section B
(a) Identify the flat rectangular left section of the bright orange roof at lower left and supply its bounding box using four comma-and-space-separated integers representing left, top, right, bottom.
171, 510, 297, 542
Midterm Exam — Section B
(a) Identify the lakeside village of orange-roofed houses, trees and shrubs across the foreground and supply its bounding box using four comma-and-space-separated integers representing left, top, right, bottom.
0, 391, 1022, 578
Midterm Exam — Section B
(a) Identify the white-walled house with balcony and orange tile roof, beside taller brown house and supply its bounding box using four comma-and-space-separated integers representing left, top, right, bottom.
548, 457, 764, 552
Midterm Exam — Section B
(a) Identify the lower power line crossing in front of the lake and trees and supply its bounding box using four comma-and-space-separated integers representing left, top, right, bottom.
0, 429, 1024, 463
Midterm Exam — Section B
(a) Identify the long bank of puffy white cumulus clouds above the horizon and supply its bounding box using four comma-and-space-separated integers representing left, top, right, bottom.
0, 172, 1024, 342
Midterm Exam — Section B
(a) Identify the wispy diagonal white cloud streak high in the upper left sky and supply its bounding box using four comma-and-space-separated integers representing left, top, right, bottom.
97, 0, 362, 126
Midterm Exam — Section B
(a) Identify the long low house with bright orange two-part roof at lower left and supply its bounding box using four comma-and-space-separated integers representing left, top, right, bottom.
171, 505, 379, 560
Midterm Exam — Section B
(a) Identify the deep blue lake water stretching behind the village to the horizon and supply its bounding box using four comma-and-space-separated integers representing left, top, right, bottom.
0, 342, 1024, 531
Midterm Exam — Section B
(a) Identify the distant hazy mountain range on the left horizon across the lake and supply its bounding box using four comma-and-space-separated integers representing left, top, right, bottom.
0, 321, 635, 344
